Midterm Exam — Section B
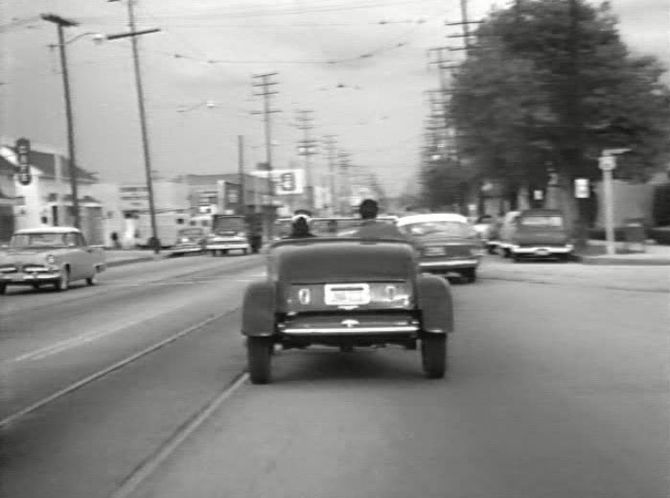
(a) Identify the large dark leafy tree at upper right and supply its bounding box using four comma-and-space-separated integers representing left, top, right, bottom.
450, 0, 670, 227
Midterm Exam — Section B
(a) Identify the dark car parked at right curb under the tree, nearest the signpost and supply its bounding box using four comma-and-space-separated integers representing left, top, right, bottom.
510, 209, 574, 261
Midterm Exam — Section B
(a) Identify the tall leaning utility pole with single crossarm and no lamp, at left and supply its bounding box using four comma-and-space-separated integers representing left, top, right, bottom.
105, 0, 161, 254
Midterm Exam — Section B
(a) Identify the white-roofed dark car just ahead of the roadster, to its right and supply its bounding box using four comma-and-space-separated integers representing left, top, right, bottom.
398, 213, 484, 282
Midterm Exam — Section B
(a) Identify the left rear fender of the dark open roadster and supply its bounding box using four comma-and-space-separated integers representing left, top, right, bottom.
242, 280, 276, 337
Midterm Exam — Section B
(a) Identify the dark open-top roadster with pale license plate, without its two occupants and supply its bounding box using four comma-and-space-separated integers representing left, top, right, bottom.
242, 237, 453, 384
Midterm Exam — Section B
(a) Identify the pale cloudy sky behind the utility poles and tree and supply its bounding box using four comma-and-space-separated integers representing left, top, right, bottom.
0, 0, 670, 195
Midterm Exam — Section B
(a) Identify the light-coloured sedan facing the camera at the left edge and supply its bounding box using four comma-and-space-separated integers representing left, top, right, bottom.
0, 227, 105, 294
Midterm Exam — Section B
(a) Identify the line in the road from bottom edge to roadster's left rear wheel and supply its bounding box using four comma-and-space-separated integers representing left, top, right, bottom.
109, 373, 249, 498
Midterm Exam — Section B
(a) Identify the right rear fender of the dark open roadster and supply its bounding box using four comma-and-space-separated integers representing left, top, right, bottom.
417, 274, 454, 334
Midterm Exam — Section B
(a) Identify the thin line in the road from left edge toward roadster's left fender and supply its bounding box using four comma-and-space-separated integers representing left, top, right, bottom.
0, 308, 237, 428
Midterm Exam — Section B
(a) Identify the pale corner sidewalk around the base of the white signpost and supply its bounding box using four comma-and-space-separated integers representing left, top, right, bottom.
575, 240, 670, 266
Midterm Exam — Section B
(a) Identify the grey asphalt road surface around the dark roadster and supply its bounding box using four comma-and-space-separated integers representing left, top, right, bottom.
0, 257, 670, 498
